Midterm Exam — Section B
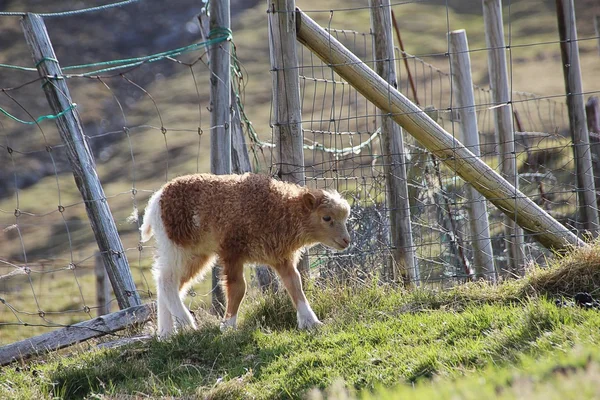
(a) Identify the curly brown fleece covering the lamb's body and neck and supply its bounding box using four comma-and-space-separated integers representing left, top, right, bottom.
160, 174, 324, 264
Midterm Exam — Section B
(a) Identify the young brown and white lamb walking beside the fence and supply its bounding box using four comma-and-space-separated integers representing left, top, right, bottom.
140, 173, 350, 338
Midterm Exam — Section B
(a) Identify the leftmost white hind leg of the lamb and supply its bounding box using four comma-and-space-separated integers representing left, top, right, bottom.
155, 248, 196, 338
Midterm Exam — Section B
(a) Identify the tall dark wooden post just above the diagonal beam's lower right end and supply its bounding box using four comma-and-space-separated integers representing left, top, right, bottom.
556, 0, 599, 237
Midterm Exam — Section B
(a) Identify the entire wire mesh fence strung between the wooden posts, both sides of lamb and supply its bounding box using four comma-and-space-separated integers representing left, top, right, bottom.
0, 0, 600, 344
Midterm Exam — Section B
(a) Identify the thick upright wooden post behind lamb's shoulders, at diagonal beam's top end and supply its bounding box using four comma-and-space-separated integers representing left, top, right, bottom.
267, 0, 309, 277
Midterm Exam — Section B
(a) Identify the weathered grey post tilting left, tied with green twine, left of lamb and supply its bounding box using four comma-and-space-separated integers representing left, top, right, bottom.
21, 13, 142, 309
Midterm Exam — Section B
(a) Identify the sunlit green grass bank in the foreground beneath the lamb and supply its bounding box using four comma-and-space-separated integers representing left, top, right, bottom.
0, 246, 600, 399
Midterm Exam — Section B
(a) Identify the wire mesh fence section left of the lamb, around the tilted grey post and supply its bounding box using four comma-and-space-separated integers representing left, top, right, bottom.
0, 0, 226, 344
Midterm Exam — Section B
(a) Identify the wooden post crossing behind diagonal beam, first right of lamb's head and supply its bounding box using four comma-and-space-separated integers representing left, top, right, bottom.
369, 0, 420, 286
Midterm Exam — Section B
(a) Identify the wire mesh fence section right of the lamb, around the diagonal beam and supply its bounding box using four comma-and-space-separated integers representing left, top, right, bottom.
262, 1, 597, 287
